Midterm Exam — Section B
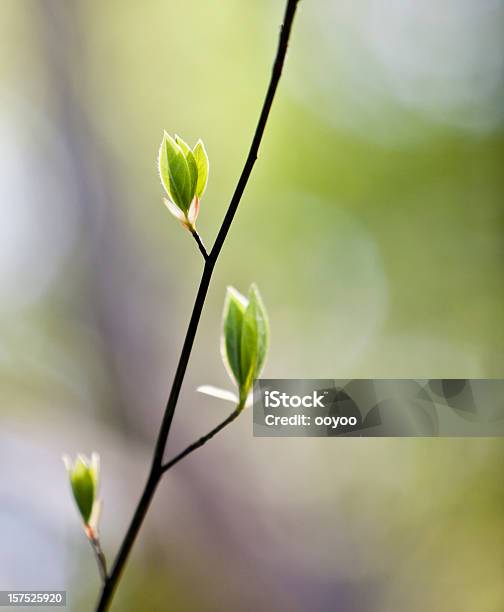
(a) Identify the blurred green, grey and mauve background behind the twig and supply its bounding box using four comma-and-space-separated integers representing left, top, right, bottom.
0, 0, 504, 612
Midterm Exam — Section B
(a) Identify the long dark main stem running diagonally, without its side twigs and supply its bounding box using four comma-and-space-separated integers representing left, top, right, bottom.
96, 0, 299, 612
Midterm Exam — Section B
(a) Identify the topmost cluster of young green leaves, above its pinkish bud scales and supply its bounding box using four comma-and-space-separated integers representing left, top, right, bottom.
158, 132, 209, 217
